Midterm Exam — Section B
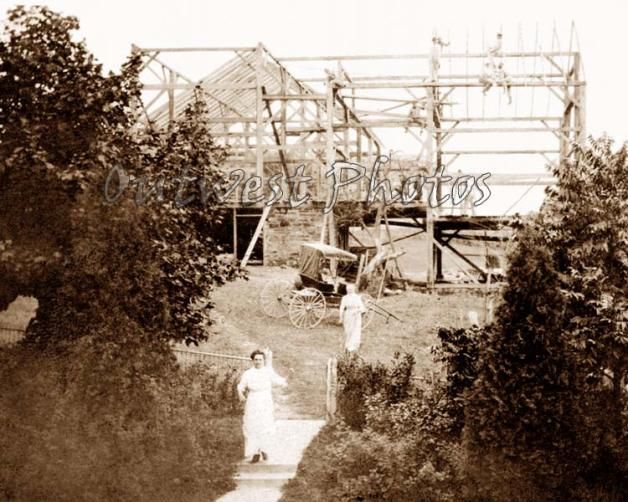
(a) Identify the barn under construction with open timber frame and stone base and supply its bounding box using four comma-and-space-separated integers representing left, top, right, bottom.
136, 27, 586, 287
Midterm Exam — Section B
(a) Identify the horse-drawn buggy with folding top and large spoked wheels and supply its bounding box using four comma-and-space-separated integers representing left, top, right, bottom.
259, 242, 382, 328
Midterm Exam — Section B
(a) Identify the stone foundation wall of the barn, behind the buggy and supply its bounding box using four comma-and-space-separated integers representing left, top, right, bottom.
264, 204, 323, 266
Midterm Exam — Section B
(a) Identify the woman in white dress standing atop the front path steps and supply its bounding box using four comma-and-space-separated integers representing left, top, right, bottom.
238, 350, 287, 463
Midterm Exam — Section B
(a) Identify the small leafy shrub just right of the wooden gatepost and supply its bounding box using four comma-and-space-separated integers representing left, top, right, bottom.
338, 353, 414, 429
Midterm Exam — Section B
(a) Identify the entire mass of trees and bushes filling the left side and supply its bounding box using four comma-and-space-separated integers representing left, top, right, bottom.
0, 7, 241, 500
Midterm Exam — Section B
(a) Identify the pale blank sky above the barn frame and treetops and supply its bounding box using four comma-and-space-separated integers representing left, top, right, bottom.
0, 0, 628, 214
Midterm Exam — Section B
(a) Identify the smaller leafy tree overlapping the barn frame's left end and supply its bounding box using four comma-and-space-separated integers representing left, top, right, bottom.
126, 93, 244, 343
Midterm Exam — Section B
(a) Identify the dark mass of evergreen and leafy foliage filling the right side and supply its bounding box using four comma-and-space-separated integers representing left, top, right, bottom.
465, 135, 628, 496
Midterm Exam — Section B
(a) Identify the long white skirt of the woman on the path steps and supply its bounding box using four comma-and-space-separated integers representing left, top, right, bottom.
242, 390, 275, 457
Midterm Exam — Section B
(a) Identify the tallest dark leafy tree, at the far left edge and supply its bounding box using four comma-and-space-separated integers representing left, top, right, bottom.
0, 7, 139, 314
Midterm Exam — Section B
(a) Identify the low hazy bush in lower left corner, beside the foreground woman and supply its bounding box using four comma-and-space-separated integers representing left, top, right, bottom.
0, 339, 242, 501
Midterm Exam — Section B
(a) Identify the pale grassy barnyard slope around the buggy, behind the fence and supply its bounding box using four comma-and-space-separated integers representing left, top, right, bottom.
200, 268, 483, 418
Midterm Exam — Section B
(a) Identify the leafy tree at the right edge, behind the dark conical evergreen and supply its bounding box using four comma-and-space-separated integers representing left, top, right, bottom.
545, 137, 628, 432
